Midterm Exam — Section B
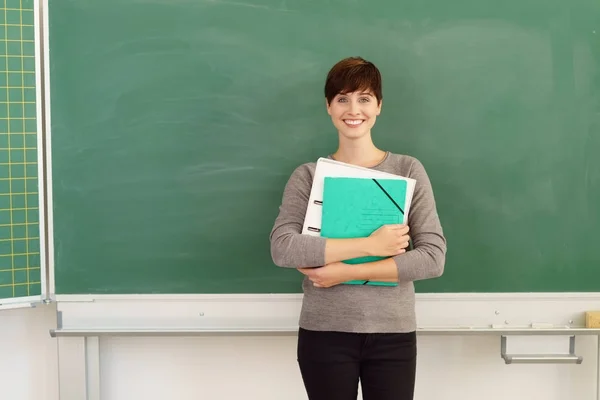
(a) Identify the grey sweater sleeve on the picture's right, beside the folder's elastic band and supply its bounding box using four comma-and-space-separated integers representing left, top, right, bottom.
394, 159, 446, 281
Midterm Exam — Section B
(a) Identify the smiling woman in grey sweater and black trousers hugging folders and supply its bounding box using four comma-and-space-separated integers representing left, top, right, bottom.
270, 57, 446, 400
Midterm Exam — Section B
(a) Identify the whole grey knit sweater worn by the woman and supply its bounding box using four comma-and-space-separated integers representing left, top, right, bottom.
270, 152, 446, 333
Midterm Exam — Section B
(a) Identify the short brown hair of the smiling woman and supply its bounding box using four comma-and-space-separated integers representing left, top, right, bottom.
325, 57, 383, 104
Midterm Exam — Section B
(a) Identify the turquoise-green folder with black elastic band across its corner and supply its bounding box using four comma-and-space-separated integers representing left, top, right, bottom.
321, 177, 407, 286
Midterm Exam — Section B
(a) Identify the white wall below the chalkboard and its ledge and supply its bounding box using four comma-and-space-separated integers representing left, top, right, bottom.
0, 306, 597, 400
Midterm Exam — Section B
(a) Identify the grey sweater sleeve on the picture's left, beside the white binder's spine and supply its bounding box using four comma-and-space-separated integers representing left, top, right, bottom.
270, 164, 326, 268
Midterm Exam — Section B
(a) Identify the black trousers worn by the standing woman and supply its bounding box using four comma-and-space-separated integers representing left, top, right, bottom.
297, 328, 417, 400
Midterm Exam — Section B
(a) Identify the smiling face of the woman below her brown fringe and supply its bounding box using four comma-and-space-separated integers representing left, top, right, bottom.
327, 92, 381, 139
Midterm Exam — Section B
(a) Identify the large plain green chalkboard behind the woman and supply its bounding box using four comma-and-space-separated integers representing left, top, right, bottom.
49, 0, 600, 294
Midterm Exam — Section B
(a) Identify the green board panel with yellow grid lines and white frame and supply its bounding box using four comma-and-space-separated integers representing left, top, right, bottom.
0, 0, 46, 307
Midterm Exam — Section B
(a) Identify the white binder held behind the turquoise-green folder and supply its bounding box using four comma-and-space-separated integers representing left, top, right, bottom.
302, 158, 416, 236
